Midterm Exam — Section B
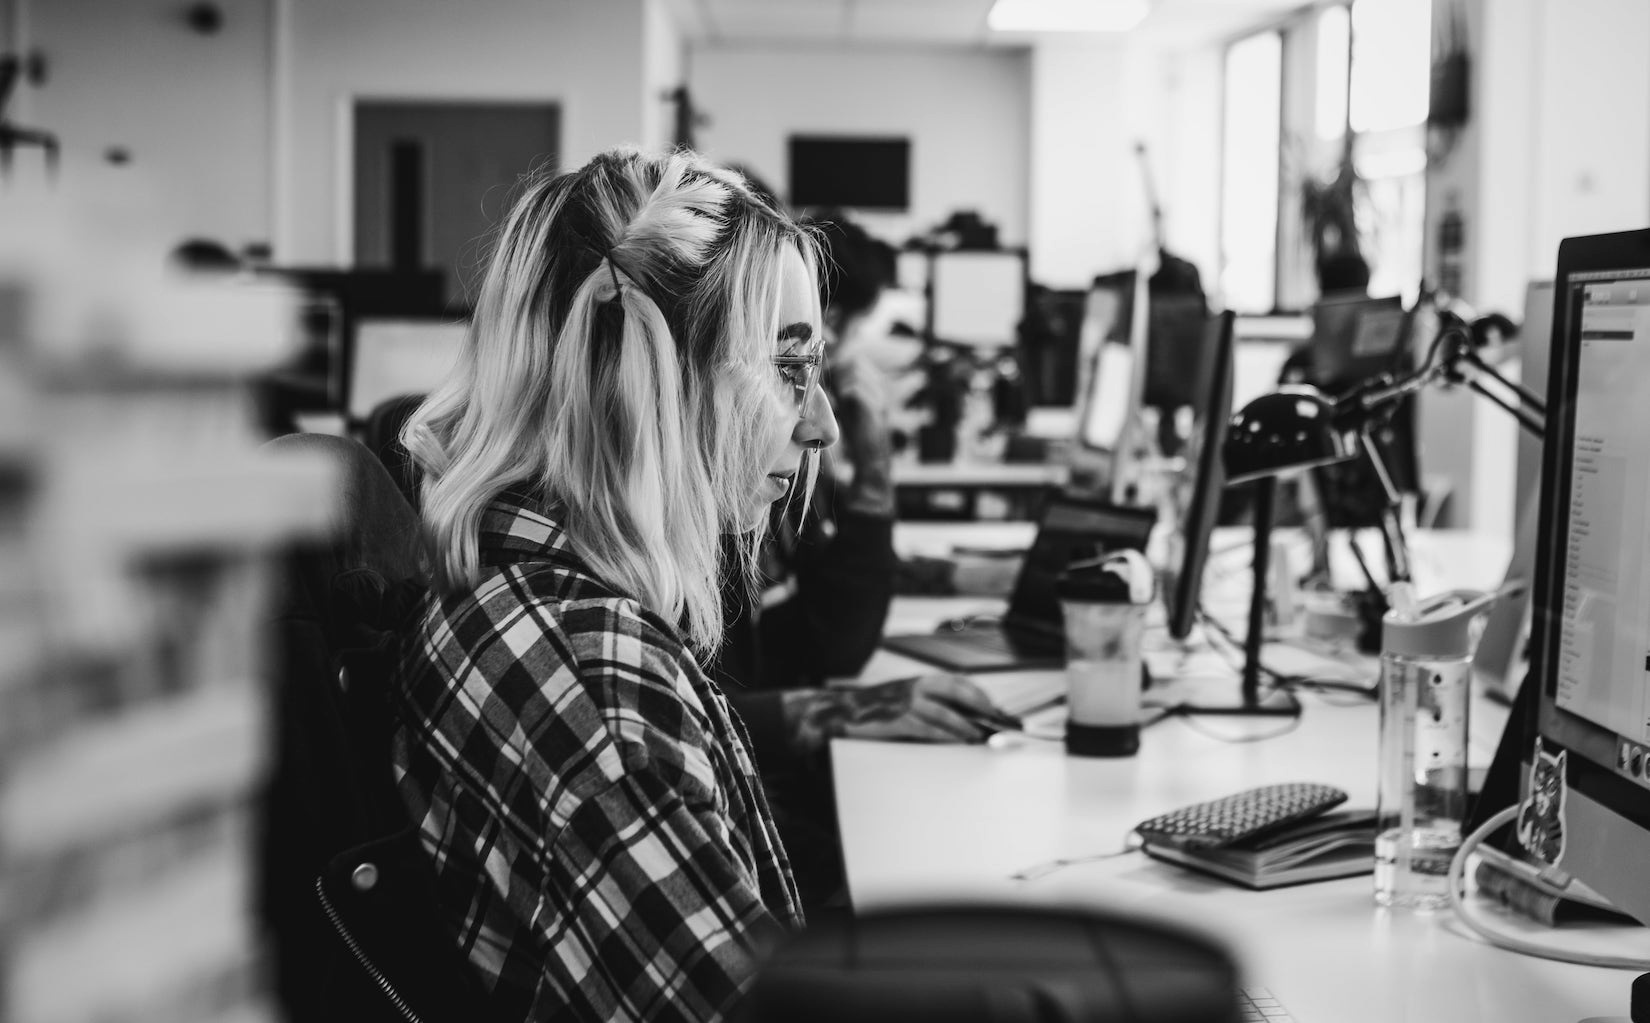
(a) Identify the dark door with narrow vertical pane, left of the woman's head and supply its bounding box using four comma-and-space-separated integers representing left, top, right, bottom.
355, 101, 561, 307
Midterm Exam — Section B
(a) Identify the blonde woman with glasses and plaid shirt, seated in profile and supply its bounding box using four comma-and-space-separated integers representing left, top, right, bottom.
393, 150, 837, 1020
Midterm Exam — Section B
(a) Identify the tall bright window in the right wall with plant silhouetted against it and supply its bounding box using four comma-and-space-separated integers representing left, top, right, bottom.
1219, 0, 1432, 312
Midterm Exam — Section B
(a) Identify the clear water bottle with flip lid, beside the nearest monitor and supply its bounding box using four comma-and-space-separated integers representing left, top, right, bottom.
1374, 584, 1493, 909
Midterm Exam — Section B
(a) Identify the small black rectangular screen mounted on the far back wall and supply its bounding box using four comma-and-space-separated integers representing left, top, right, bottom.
789, 135, 911, 210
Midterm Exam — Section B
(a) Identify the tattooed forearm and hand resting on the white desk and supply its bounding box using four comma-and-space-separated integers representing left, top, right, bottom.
784, 673, 1002, 751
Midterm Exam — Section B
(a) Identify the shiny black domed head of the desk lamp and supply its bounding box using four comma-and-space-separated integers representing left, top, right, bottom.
1221, 384, 1358, 483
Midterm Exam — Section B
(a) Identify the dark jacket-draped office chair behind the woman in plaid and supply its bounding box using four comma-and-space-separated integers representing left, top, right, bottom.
257, 434, 487, 1023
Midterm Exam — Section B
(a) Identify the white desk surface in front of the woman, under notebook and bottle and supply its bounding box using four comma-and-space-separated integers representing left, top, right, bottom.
832, 526, 1643, 1023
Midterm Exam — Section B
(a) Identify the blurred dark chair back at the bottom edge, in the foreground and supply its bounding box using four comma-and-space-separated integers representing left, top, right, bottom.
739, 906, 1238, 1023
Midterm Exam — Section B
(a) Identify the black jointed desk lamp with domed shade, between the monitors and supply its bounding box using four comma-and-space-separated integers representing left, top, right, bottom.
1207, 312, 1546, 714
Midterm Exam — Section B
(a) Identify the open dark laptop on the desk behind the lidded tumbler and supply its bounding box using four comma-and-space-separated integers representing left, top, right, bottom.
883, 493, 1157, 673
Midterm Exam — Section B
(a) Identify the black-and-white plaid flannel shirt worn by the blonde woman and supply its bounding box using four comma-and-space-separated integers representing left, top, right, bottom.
393, 495, 802, 1020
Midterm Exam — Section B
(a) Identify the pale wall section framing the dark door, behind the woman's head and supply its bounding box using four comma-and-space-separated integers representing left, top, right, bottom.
274, 0, 653, 262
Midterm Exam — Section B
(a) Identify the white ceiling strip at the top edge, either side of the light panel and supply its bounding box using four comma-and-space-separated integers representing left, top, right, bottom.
672, 0, 1310, 46
